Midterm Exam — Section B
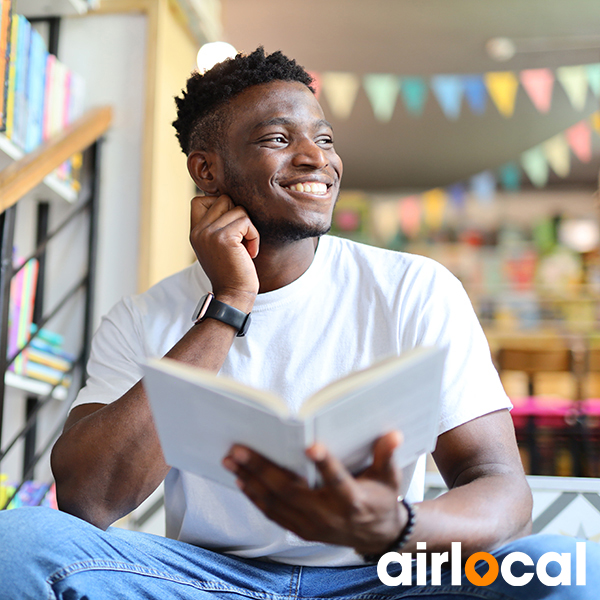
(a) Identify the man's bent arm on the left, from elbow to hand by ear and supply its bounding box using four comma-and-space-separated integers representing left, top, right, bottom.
51, 196, 258, 529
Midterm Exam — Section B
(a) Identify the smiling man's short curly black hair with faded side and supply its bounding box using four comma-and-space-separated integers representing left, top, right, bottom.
173, 46, 315, 154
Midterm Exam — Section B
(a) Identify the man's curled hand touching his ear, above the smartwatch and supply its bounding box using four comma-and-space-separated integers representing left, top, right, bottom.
190, 194, 259, 310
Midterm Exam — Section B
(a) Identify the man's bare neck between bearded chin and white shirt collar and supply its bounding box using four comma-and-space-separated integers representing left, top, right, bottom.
254, 238, 319, 294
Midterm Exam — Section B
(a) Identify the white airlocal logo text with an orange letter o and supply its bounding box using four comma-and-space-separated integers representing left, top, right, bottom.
377, 542, 586, 586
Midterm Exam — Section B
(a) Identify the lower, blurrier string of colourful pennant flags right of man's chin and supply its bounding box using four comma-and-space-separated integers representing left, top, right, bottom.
337, 111, 600, 238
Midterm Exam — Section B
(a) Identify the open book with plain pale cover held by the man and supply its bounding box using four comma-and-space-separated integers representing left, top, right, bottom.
143, 347, 446, 487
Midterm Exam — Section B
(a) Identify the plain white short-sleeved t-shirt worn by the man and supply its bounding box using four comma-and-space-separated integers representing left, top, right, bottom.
74, 236, 511, 566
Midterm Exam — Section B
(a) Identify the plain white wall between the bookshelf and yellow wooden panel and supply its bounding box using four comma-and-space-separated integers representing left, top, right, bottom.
58, 14, 146, 326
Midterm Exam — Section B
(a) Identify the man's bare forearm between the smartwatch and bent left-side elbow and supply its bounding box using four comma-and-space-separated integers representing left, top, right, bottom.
52, 310, 249, 529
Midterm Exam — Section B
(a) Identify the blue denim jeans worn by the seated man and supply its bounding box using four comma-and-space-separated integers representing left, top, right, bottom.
0, 508, 600, 600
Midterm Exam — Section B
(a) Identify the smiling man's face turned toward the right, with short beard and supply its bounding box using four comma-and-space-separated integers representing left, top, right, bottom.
219, 81, 342, 244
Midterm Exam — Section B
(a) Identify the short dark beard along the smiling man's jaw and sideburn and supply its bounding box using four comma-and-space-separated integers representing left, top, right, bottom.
224, 160, 337, 246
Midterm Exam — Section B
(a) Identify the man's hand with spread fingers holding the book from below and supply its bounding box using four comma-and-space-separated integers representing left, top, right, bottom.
223, 432, 407, 554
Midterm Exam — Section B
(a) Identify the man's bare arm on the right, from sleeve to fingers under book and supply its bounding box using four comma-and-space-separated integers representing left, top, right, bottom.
224, 410, 532, 554
